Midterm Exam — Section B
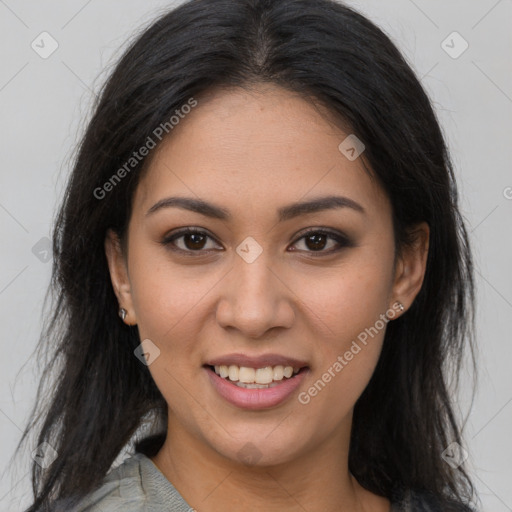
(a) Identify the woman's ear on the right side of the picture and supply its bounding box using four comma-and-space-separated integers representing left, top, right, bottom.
392, 222, 430, 310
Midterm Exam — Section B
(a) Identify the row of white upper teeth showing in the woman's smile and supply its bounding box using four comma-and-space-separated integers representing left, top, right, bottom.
210, 364, 300, 388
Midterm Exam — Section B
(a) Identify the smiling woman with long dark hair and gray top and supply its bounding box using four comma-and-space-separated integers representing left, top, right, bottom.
17, 0, 480, 512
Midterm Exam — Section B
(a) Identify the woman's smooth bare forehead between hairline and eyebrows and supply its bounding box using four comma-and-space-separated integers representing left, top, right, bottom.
134, 85, 389, 222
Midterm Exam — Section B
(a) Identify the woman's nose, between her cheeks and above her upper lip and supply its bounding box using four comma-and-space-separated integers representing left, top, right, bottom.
216, 251, 295, 338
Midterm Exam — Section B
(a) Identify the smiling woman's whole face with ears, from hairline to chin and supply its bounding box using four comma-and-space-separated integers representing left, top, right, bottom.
106, 86, 428, 465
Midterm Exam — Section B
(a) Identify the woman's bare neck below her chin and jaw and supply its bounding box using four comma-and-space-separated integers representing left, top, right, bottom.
151, 417, 390, 512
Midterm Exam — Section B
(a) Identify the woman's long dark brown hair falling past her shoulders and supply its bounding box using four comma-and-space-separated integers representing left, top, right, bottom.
14, 0, 475, 512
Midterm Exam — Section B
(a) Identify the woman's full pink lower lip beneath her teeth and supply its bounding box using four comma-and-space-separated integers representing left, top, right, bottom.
205, 367, 308, 410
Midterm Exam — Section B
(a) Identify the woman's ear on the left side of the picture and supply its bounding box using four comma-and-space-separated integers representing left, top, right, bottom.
105, 229, 137, 325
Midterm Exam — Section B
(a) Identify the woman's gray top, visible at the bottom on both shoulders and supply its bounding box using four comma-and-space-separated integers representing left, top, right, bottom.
54, 452, 460, 512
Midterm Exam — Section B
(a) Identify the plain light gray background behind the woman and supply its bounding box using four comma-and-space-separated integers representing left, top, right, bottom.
0, 0, 512, 512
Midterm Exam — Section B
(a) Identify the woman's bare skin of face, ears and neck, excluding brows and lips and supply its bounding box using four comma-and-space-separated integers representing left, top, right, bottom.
105, 85, 429, 512
